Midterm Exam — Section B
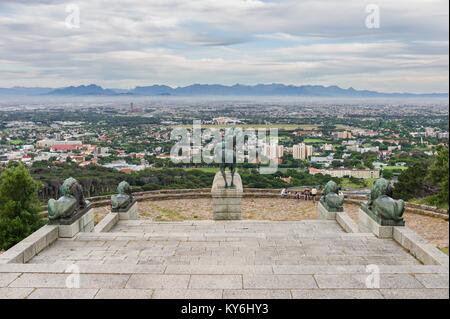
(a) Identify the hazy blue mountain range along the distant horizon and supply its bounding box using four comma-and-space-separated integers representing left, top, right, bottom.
0, 84, 448, 98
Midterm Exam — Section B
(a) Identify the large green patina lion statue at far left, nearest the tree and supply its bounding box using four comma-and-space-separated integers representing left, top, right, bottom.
48, 177, 90, 221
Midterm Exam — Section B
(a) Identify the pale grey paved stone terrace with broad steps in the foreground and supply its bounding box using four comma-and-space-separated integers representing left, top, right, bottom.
0, 220, 449, 299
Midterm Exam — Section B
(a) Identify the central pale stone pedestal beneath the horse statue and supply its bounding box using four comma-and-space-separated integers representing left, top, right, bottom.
211, 172, 244, 220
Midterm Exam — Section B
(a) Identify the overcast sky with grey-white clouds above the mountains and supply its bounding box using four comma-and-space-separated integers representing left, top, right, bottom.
0, 0, 449, 92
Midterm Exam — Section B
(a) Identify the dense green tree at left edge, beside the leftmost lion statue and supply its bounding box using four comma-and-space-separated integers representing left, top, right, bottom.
0, 164, 43, 250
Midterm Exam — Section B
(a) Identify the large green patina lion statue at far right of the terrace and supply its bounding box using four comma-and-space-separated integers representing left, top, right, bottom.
361, 178, 405, 226
